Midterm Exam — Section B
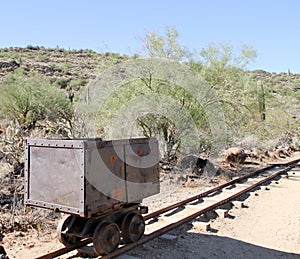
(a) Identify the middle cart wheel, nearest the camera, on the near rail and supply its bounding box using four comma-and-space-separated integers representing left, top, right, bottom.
93, 221, 121, 255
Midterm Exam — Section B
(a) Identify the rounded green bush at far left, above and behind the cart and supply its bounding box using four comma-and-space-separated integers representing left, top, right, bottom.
0, 69, 73, 129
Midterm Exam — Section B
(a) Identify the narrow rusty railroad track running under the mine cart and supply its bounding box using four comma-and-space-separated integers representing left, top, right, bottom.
37, 159, 300, 259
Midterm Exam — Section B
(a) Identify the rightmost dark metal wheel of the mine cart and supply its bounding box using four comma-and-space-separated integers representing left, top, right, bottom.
121, 212, 145, 243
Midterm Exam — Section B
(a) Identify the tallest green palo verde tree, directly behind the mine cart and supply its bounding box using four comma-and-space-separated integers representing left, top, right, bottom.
77, 28, 217, 159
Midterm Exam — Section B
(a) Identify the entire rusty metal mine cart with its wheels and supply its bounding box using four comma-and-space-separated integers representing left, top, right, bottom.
25, 138, 159, 254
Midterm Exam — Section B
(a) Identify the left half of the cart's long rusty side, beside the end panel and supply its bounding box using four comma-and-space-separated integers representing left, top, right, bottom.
85, 141, 127, 217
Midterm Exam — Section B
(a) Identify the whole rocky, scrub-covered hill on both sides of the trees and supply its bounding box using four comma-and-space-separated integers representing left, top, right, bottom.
0, 46, 300, 146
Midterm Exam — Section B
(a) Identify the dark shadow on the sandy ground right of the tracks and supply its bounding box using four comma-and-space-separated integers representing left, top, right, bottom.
128, 224, 300, 259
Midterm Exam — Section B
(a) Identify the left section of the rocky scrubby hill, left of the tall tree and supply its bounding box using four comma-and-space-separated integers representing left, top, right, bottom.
0, 46, 127, 91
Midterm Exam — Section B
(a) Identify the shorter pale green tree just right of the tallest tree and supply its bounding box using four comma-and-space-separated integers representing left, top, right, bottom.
190, 43, 260, 140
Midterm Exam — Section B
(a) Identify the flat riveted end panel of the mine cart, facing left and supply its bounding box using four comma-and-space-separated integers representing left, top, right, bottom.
25, 140, 84, 216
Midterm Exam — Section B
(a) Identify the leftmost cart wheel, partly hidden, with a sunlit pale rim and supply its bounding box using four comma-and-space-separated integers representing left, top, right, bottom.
57, 215, 81, 247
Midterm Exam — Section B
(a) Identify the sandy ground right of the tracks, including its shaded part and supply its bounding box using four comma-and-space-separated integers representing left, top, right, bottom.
130, 159, 300, 258
